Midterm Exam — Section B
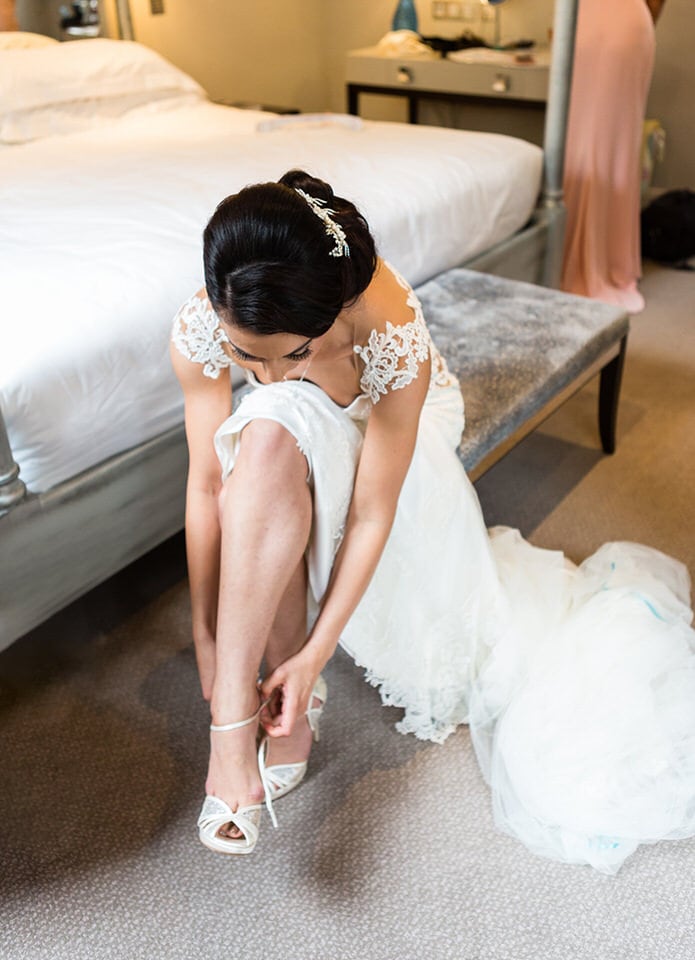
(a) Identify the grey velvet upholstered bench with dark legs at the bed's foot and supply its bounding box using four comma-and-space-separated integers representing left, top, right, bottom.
416, 269, 629, 480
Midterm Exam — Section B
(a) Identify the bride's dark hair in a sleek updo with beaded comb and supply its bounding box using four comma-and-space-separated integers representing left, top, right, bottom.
203, 170, 376, 337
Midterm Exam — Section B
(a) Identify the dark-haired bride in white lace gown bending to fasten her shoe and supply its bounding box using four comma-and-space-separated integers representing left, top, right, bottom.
171, 170, 695, 872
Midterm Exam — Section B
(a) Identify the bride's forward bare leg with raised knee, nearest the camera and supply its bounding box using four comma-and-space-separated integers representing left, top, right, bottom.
206, 420, 312, 836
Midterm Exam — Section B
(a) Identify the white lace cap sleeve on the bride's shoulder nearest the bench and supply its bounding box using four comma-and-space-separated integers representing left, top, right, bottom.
353, 263, 457, 403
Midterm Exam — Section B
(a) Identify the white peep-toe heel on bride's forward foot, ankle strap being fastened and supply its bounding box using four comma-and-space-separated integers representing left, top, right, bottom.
198, 703, 278, 854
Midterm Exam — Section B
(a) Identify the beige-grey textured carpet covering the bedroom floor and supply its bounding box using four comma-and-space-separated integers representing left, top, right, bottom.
0, 269, 695, 960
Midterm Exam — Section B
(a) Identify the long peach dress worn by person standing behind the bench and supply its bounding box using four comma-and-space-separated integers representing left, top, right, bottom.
561, 0, 655, 313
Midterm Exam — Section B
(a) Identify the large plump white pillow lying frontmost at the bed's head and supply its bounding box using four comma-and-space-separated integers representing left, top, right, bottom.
0, 37, 206, 143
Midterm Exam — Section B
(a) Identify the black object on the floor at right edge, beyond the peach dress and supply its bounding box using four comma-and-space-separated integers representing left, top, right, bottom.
640, 190, 695, 270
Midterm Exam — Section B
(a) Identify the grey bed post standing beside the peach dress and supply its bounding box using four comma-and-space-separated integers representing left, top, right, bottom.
541, 0, 579, 287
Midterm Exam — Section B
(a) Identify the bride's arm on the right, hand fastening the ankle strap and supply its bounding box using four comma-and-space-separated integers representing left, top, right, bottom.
262, 278, 430, 736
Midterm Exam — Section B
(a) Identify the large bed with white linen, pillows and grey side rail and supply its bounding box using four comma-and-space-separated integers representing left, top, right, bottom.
0, 1, 576, 649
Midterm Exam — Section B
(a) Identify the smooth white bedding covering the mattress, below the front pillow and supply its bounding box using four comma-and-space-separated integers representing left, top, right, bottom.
0, 71, 542, 492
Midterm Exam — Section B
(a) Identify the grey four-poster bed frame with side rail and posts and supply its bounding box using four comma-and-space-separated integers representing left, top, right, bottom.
0, 0, 578, 650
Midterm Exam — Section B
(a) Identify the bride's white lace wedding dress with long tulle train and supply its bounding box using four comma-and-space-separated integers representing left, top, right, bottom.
173, 266, 695, 873
